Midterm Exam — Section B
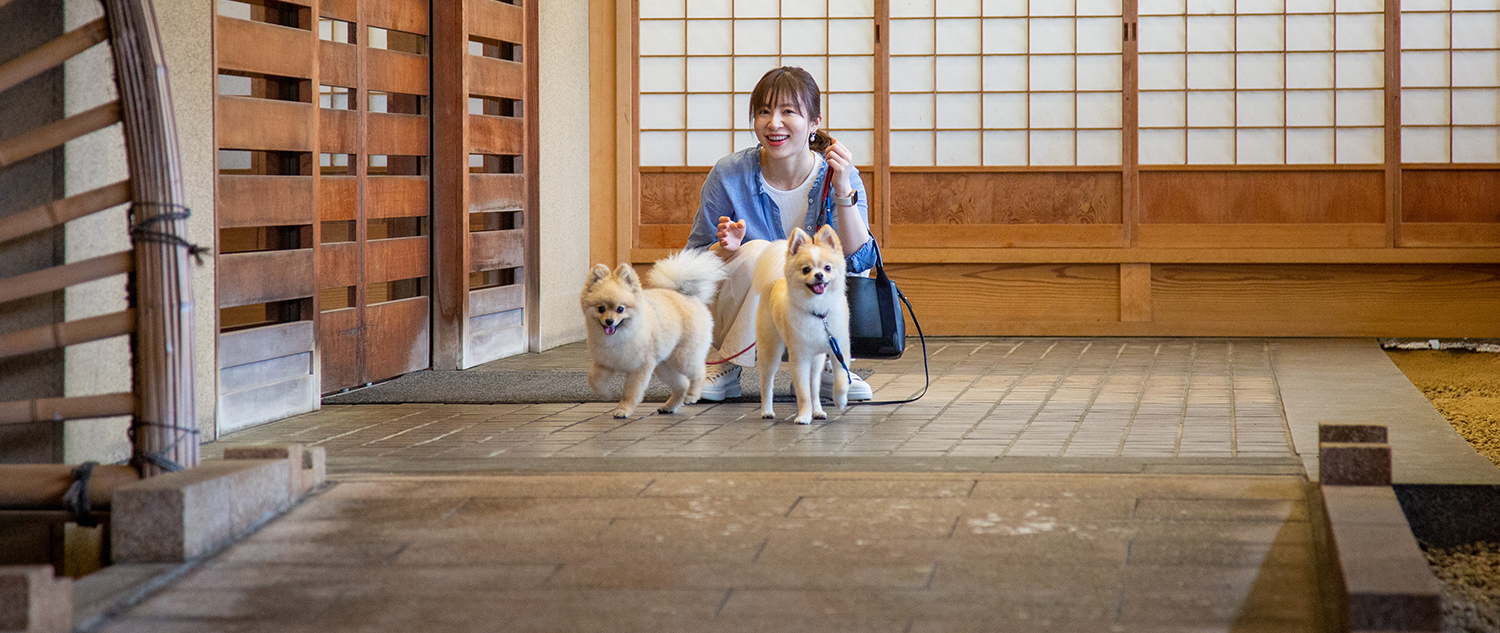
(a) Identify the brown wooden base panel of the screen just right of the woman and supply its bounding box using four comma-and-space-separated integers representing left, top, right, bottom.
891, 173, 1122, 225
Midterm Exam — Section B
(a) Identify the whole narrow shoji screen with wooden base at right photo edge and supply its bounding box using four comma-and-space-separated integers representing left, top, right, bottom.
1401, 0, 1500, 246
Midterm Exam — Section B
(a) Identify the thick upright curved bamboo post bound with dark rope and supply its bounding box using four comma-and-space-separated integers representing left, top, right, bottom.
104, 0, 198, 477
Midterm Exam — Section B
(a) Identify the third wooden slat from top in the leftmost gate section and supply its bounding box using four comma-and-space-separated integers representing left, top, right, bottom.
218, 176, 314, 230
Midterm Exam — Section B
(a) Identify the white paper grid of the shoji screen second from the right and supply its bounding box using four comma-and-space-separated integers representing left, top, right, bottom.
1140, 0, 1385, 165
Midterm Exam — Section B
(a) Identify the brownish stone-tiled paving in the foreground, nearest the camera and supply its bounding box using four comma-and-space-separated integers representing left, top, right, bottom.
102, 473, 1322, 633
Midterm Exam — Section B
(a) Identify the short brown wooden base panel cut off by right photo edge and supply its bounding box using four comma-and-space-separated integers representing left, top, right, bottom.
1401, 170, 1500, 225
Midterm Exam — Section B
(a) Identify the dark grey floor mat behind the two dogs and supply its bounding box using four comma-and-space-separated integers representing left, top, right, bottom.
323, 365, 870, 405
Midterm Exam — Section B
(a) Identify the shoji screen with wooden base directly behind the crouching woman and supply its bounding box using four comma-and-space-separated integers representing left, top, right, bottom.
636, 0, 878, 249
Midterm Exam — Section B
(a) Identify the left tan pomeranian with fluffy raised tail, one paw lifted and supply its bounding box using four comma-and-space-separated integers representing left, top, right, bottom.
579, 251, 725, 417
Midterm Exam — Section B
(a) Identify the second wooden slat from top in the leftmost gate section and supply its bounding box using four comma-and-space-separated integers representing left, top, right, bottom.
215, 96, 317, 152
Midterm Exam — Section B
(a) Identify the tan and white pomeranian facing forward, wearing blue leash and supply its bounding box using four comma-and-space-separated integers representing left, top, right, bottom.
752, 225, 849, 425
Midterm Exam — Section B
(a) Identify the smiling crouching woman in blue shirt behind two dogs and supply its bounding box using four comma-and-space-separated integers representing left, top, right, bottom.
687, 66, 875, 401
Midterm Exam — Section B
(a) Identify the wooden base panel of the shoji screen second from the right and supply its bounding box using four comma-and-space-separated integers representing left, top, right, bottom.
1140, 168, 1386, 225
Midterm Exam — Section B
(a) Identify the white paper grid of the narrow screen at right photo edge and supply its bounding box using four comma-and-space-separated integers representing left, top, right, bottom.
1401, 0, 1500, 164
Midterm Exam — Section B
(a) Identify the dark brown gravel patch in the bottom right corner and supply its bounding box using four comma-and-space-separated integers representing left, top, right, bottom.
1424, 543, 1500, 633
